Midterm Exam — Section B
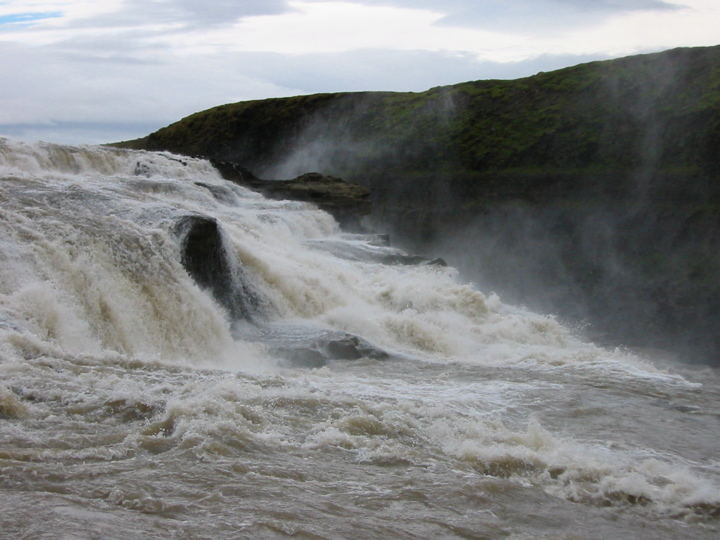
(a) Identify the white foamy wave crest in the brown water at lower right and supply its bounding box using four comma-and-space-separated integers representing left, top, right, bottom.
434, 419, 720, 515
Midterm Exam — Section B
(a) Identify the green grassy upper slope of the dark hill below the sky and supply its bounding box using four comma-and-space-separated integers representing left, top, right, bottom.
124, 47, 720, 184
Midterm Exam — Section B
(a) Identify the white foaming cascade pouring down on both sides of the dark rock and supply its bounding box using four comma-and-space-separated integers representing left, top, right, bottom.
0, 139, 688, 382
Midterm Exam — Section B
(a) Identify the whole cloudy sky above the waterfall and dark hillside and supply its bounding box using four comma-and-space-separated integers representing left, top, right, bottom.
0, 0, 720, 144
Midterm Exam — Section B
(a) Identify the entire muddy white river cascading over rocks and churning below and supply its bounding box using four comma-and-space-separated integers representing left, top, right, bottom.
0, 139, 720, 539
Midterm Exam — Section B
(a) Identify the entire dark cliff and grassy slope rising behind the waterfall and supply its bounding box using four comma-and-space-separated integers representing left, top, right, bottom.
118, 47, 720, 361
